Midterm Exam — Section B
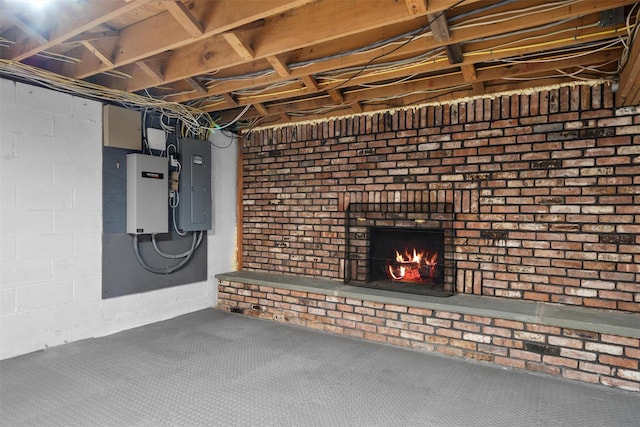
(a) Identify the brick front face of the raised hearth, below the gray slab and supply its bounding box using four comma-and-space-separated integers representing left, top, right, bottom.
218, 281, 640, 391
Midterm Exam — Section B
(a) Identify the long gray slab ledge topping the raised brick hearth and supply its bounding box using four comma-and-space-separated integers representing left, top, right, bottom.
215, 271, 640, 338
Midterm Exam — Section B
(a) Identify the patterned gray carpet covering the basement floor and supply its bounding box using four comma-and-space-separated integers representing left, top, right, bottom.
0, 309, 640, 426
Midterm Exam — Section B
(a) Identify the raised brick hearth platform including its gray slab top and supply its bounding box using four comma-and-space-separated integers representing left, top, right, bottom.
216, 271, 640, 391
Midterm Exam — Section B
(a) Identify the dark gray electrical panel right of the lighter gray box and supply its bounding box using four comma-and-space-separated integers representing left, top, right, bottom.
177, 139, 211, 231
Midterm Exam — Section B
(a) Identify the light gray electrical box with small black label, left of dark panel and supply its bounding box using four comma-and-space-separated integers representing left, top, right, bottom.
127, 154, 169, 234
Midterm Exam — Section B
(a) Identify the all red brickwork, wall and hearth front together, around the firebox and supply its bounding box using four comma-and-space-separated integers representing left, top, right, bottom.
219, 85, 640, 390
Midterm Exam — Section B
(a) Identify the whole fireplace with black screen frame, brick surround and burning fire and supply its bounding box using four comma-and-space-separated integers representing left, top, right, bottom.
344, 201, 456, 296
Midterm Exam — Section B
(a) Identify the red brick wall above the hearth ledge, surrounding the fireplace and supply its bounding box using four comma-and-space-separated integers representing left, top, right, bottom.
242, 86, 640, 312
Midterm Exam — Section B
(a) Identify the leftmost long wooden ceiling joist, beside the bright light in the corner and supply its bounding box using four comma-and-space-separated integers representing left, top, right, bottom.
7, 0, 151, 61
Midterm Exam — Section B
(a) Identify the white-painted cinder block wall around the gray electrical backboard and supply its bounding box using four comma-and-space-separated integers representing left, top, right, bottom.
0, 79, 237, 359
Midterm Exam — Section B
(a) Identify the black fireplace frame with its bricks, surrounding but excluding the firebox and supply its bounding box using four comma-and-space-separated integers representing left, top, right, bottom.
344, 202, 456, 296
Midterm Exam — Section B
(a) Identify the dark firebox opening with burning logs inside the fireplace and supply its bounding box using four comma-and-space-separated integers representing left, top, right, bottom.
367, 227, 445, 293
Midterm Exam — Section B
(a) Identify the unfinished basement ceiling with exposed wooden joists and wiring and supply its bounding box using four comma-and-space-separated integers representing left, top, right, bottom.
0, 0, 640, 128
